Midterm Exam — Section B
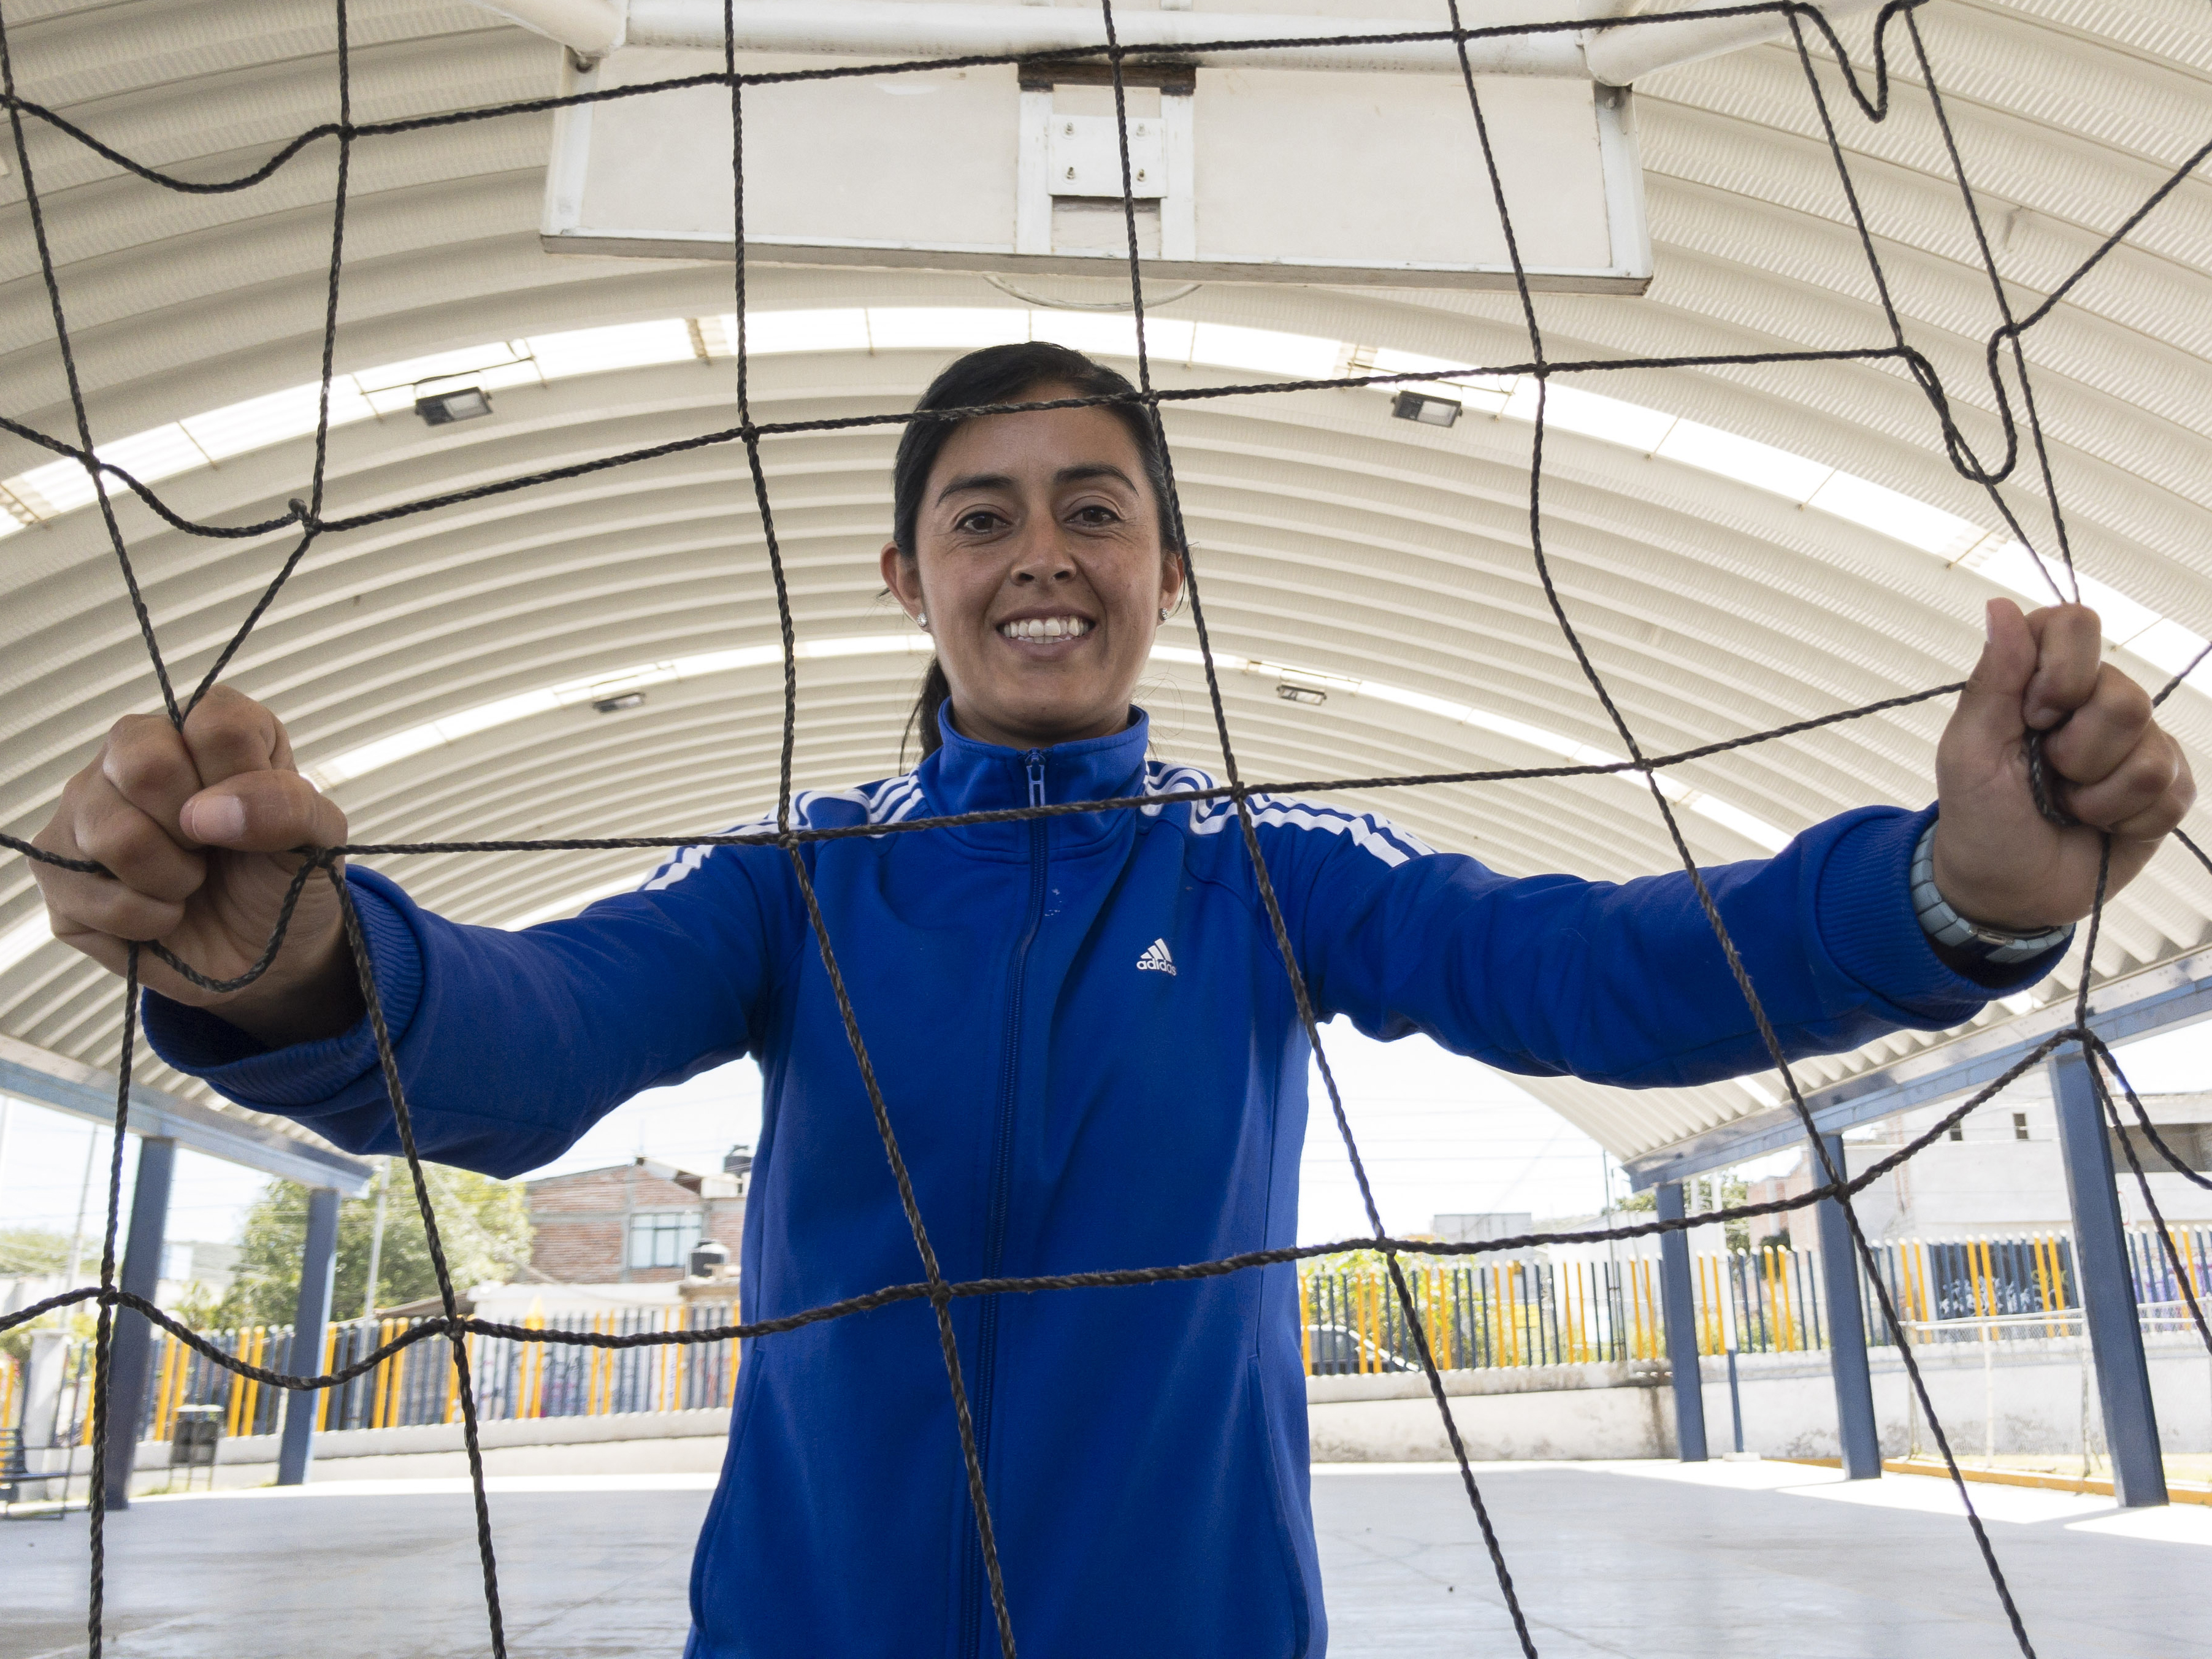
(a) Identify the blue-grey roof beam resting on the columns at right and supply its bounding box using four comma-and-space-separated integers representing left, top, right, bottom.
1621, 951, 2212, 1192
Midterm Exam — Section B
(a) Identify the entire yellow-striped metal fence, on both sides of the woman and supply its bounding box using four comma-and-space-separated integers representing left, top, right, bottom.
0, 1228, 2212, 1444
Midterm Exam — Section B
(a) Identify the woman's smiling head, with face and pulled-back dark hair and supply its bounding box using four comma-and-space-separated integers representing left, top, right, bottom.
882, 340, 1184, 754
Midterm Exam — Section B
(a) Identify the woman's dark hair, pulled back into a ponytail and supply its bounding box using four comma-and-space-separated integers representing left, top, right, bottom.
892, 351, 1177, 759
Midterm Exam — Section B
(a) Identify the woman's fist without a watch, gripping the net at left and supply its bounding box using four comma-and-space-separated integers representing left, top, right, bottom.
31, 686, 363, 1046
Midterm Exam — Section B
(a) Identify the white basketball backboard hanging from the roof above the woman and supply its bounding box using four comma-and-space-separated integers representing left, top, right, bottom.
526, 0, 1650, 292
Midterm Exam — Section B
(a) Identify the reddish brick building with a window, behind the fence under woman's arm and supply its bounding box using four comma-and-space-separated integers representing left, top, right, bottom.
526, 1146, 752, 1285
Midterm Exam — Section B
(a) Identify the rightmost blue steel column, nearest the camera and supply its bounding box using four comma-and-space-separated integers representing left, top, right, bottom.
2046, 1046, 2165, 1509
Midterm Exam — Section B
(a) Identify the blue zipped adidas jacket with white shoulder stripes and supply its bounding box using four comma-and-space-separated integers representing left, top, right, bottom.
146, 719, 2044, 1659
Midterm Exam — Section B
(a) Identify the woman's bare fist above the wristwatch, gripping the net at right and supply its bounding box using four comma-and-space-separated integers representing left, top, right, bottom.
1934, 599, 2197, 931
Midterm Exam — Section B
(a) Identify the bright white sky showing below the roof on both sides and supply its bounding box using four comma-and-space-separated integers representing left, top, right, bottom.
0, 1022, 2212, 1272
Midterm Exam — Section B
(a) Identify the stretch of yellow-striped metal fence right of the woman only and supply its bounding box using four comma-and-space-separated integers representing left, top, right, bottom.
1298, 1228, 2212, 1376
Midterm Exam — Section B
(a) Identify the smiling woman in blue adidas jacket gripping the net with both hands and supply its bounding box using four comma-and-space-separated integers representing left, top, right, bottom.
40, 345, 2190, 1659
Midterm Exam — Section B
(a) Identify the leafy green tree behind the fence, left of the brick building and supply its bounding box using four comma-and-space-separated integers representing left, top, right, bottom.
215, 1162, 531, 1325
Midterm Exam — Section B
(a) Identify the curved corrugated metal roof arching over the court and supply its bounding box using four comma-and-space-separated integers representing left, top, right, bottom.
0, 0, 2212, 1157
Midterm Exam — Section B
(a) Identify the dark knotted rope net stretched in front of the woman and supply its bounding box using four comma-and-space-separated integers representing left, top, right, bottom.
0, 0, 2212, 1659
